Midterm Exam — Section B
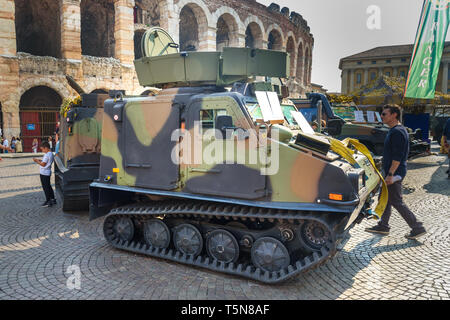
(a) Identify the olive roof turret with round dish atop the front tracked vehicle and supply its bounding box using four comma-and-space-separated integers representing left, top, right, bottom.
134, 27, 289, 87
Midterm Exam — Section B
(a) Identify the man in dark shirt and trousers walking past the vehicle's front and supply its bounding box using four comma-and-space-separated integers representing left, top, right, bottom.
366, 105, 426, 239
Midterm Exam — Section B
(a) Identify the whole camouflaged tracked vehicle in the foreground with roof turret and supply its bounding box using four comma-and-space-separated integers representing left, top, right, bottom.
90, 28, 381, 283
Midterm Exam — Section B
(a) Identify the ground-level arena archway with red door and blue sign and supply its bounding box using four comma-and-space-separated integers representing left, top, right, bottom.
19, 86, 62, 152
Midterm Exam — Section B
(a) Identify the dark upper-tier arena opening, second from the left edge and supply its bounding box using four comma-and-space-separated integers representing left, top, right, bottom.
81, 0, 115, 57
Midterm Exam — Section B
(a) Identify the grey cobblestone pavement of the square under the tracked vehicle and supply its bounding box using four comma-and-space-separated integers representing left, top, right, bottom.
0, 146, 450, 300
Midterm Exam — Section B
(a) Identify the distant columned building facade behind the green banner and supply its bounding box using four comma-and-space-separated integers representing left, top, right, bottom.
339, 42, 450, 94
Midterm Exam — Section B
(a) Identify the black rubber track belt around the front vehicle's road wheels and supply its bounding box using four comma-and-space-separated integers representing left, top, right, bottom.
105, 201, 337, 284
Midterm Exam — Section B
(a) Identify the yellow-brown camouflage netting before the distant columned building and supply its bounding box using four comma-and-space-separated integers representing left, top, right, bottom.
328, 76, 450, 109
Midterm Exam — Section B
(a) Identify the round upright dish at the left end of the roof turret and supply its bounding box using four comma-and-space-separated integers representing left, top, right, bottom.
141, 27, 178, 57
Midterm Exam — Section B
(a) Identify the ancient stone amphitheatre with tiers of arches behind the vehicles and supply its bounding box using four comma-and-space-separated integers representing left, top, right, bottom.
0, 0, 314, 151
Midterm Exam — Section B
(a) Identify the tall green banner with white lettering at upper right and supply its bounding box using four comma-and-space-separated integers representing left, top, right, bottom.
404, 0, 450, 99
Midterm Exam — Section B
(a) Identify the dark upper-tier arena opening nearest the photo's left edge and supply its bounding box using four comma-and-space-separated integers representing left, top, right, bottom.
15, 0, 61, 58
